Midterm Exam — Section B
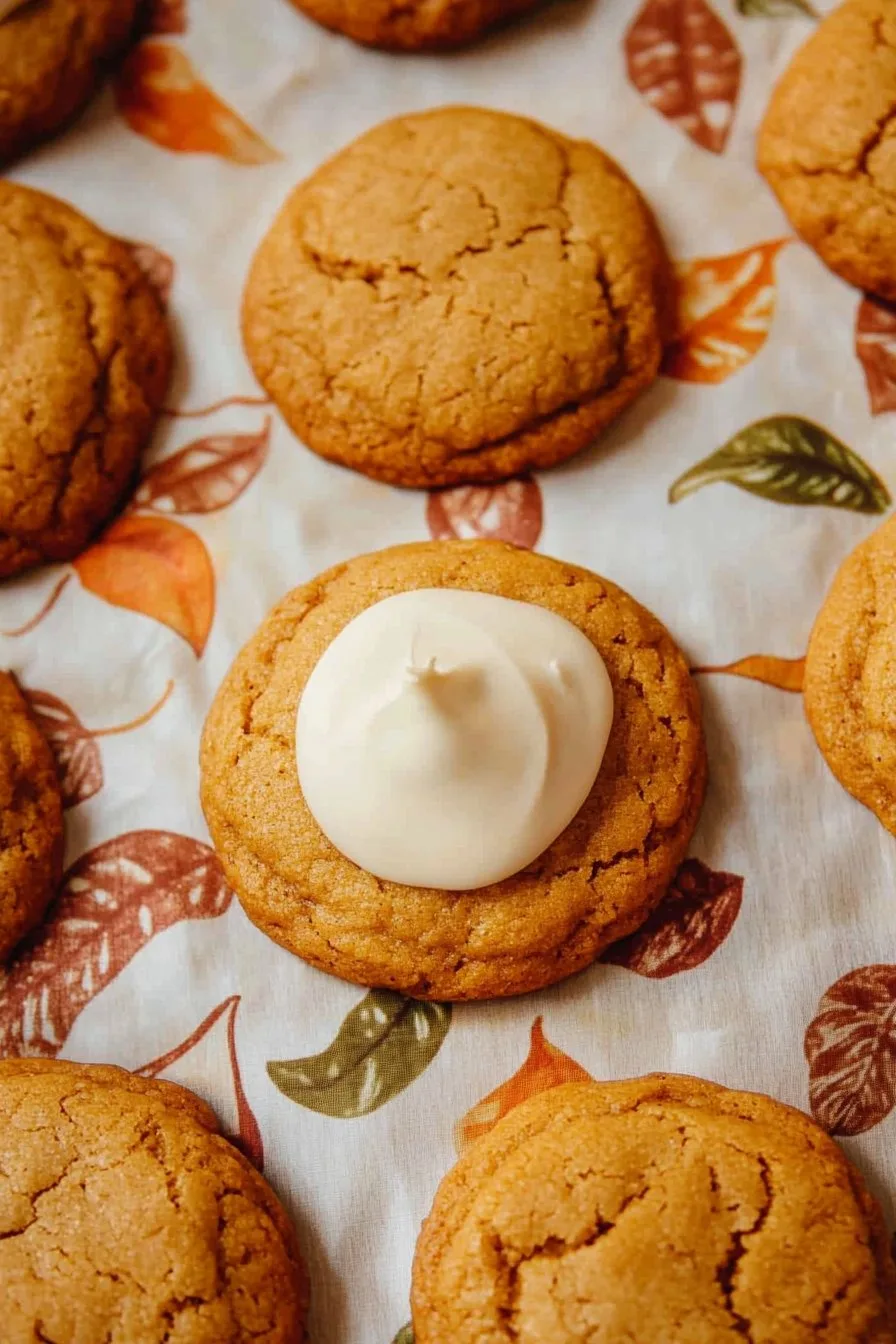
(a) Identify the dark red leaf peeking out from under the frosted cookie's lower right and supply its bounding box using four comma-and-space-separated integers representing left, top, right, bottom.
600, 859, 744, 980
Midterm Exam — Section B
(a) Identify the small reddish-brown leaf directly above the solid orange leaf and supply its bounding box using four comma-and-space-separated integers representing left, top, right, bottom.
134, 417, 270, 513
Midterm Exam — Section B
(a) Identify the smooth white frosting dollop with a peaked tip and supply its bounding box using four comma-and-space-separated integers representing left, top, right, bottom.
296, 589, 613, 891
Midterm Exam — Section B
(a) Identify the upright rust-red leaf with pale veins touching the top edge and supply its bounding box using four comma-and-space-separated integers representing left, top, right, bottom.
625, 0, 742, 153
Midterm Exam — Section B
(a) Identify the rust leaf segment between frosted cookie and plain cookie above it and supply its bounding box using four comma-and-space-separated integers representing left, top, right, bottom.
426, 476, 543, 550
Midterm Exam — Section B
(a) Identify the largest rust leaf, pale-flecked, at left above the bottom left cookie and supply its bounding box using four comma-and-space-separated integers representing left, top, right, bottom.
0, 831, 232, 1059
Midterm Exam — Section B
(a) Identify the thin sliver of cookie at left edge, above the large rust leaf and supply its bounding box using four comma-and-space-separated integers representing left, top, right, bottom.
0, 672, 63, 961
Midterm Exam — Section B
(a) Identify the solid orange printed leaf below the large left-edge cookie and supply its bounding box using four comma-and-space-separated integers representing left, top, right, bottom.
74, 515, 215, 657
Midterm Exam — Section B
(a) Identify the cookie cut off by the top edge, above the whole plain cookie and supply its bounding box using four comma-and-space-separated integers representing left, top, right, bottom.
283, 0, 540, 51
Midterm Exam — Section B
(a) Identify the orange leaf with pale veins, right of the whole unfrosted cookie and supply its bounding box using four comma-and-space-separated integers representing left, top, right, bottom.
662, 238, 787, 383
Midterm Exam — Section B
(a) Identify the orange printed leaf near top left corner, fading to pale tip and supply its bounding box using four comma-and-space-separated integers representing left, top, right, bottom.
116, 40, 279, 164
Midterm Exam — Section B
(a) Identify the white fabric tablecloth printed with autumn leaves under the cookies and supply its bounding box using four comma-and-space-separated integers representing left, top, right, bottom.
0, 0, 896, 1344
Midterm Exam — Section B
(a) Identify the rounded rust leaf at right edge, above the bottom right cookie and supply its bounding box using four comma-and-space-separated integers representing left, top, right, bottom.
805, 965, 896, 1136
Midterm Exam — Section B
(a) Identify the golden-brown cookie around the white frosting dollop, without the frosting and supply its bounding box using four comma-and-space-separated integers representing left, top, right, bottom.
200, 540, 705, 1000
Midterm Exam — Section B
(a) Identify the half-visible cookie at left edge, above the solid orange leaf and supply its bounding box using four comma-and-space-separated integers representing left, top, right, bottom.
0, 178, 172, 578
